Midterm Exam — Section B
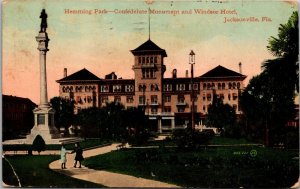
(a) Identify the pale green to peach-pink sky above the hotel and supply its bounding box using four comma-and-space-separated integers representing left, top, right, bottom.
2, 0, 298, 104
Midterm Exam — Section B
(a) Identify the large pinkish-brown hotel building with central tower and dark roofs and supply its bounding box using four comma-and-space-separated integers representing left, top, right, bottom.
57, 39, 246, 133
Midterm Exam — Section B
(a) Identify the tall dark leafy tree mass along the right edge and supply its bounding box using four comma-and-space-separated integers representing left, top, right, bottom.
240, 12, 299, 145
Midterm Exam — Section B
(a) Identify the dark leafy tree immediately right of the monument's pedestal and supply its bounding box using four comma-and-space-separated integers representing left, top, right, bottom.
50, 97, 74, 134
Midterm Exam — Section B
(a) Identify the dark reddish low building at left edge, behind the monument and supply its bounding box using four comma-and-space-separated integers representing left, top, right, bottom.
2, 95, 37, 140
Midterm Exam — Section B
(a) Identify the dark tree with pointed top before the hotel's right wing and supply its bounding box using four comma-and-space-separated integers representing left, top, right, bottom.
206, 92, 236, 134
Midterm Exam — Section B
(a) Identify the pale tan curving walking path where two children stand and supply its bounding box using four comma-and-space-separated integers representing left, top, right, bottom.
49, 144, 179, 188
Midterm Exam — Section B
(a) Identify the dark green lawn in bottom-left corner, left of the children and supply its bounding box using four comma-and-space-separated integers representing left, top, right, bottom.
3, 155, 103, 188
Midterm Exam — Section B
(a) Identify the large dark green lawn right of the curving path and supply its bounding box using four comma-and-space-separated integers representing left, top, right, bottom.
84, 147, 299, 188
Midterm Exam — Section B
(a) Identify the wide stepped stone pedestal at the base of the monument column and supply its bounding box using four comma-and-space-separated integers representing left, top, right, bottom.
26, 106, 60, 144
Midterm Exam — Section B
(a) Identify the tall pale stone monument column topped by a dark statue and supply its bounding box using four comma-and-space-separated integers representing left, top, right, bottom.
26, 9, 59, 144
